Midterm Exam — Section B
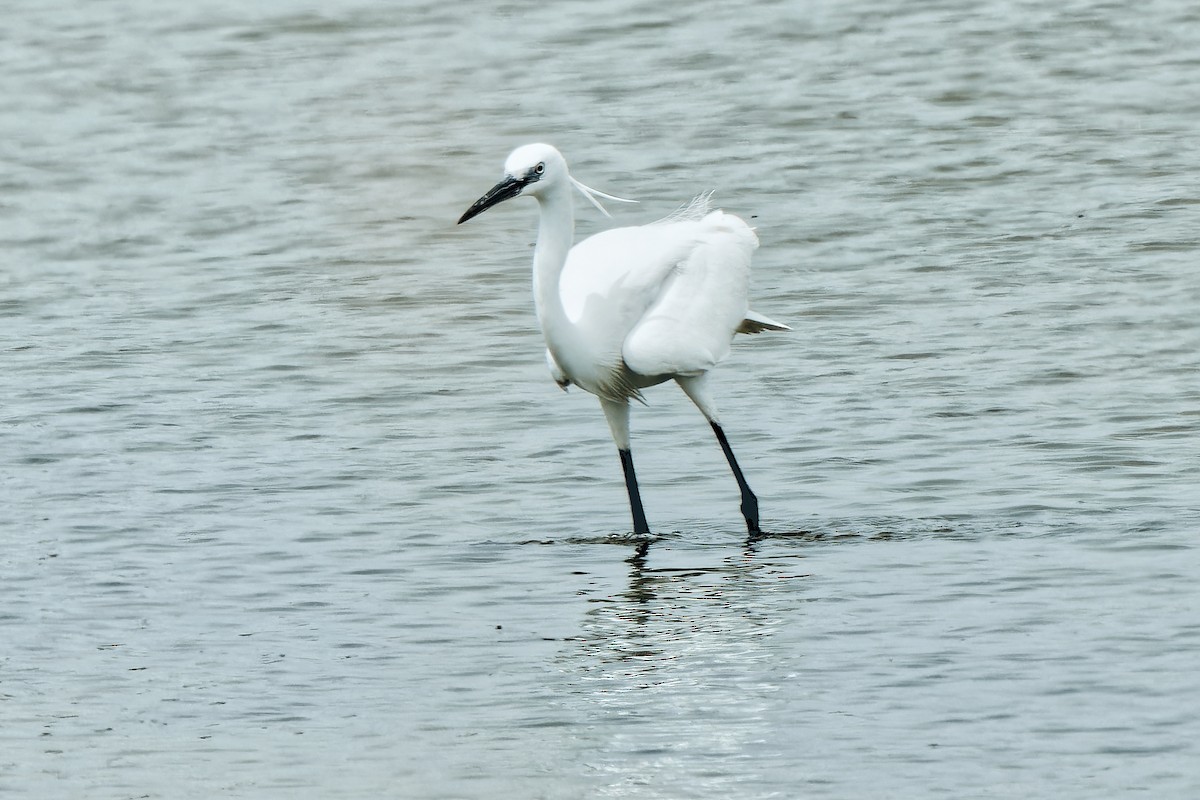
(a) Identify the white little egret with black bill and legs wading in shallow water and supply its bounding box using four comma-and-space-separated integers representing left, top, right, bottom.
458, 144, 791, 535
